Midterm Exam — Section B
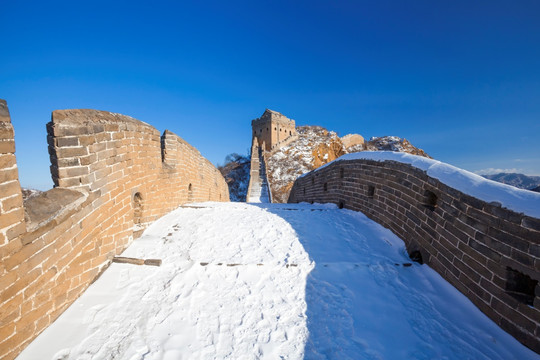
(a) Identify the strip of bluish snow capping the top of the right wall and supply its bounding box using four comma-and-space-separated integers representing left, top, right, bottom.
315, 151, 540, 218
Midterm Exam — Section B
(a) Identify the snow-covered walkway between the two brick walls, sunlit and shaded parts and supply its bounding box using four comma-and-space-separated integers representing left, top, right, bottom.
18, 203, 540, 360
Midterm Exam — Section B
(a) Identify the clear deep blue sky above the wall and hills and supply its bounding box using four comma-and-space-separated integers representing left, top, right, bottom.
0, 0, 540, 189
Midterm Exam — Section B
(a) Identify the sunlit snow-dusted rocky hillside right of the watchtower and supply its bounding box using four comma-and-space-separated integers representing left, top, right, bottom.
267, 126, 430, 202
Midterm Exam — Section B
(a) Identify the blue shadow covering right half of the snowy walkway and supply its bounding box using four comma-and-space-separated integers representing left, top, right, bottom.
250, 204, 538, 360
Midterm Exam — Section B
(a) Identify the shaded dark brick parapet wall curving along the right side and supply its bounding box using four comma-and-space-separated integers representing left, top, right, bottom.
289, 160, 540, 353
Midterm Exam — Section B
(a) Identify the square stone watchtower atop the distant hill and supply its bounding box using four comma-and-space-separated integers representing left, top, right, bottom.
251, 109, 297, 151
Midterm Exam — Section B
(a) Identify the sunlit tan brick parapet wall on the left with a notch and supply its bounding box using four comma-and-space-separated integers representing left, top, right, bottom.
0, 100, 229, 359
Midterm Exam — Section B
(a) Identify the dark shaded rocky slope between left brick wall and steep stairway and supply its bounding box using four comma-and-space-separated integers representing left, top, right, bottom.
218, 154, 250, 201
